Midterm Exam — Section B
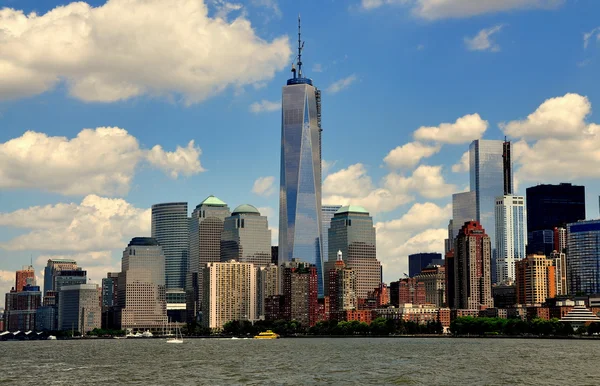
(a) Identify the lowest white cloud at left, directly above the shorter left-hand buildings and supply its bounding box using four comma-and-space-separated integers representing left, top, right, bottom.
0, 195, 150, 252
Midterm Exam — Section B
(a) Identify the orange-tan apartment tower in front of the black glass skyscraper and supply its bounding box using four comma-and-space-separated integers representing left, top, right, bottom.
516, 255, 556, 305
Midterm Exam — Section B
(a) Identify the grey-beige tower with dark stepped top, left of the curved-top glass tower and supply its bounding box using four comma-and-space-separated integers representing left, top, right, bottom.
117, 237, 167, 331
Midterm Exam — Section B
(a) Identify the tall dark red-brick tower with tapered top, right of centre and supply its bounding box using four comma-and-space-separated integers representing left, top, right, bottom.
449, 221, 494, 309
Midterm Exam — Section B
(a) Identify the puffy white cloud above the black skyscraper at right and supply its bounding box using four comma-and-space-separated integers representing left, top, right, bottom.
500, 94, 592, 139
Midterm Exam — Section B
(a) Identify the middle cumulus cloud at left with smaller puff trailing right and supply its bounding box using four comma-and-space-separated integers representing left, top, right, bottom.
0, 128, 204, 195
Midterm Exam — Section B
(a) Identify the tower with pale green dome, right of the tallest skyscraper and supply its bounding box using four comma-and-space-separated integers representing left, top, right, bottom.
329, 205, 381, 299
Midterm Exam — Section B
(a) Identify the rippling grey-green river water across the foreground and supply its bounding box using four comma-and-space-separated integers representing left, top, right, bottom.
0, 338, 600, 386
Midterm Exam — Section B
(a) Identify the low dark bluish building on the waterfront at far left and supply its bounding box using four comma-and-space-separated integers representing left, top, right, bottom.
4, 285, 42, 332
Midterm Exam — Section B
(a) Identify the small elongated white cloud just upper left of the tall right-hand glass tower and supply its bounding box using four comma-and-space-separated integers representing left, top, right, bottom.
414, 114, 488, 145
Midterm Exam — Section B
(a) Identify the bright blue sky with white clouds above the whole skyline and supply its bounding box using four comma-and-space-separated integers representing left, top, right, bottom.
0, 0, 600, 307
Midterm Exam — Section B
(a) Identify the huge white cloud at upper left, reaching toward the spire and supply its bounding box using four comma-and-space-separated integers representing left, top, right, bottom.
0, 0, 291, 104
